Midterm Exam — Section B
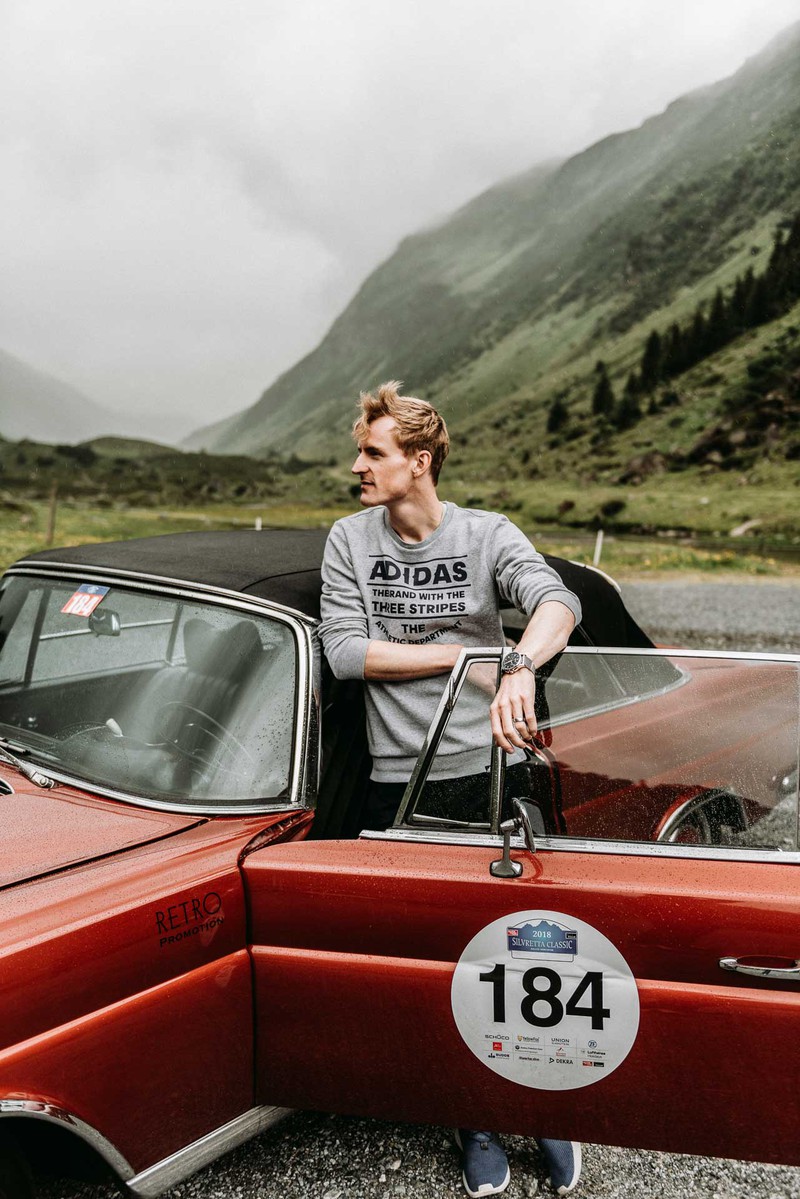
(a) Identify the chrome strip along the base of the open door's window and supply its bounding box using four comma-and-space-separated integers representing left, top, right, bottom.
359, 826, 800, 866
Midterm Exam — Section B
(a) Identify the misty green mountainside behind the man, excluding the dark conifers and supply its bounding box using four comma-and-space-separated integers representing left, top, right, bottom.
185, 18, 800, 484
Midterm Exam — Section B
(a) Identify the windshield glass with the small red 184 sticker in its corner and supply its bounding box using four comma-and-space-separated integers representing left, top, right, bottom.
0, 577, 296, 805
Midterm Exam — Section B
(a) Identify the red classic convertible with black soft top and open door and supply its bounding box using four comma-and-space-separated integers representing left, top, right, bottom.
0, 531, 800, 1199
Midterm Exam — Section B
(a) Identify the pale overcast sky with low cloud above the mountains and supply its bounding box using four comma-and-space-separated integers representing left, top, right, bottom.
0, 0, 800, 436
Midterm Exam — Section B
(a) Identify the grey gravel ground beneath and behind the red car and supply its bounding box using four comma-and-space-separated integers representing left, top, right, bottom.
46, 583, 800, 1199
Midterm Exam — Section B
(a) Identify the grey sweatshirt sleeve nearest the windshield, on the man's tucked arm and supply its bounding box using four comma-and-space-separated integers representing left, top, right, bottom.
319, 522, 369, 679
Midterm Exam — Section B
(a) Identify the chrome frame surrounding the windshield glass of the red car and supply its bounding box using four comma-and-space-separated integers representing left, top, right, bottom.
6, 562, 319, 815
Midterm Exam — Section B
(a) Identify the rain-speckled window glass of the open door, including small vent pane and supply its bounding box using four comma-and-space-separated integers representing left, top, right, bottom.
405, 649, 800, 851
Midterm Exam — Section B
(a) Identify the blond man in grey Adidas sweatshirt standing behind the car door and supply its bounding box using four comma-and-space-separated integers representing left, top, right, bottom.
320, 381, 581, 1197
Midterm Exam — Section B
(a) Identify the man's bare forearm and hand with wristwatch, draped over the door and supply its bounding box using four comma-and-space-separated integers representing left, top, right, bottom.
489, 600, 575, 753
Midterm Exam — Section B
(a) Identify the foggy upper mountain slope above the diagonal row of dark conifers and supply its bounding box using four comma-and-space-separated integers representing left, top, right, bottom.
190, 25, 800, 454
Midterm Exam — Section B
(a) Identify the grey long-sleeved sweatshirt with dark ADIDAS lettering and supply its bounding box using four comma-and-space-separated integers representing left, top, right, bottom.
319, 504, 581, 783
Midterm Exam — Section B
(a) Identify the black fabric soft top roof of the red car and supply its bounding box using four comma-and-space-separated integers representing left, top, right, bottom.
22, 529, 652, 647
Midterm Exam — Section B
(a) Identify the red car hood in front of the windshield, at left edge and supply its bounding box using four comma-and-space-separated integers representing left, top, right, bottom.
0, 763, 203, 887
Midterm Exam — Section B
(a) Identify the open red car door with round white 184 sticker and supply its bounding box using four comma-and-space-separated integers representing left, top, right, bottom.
245, 651, 800, 1163
